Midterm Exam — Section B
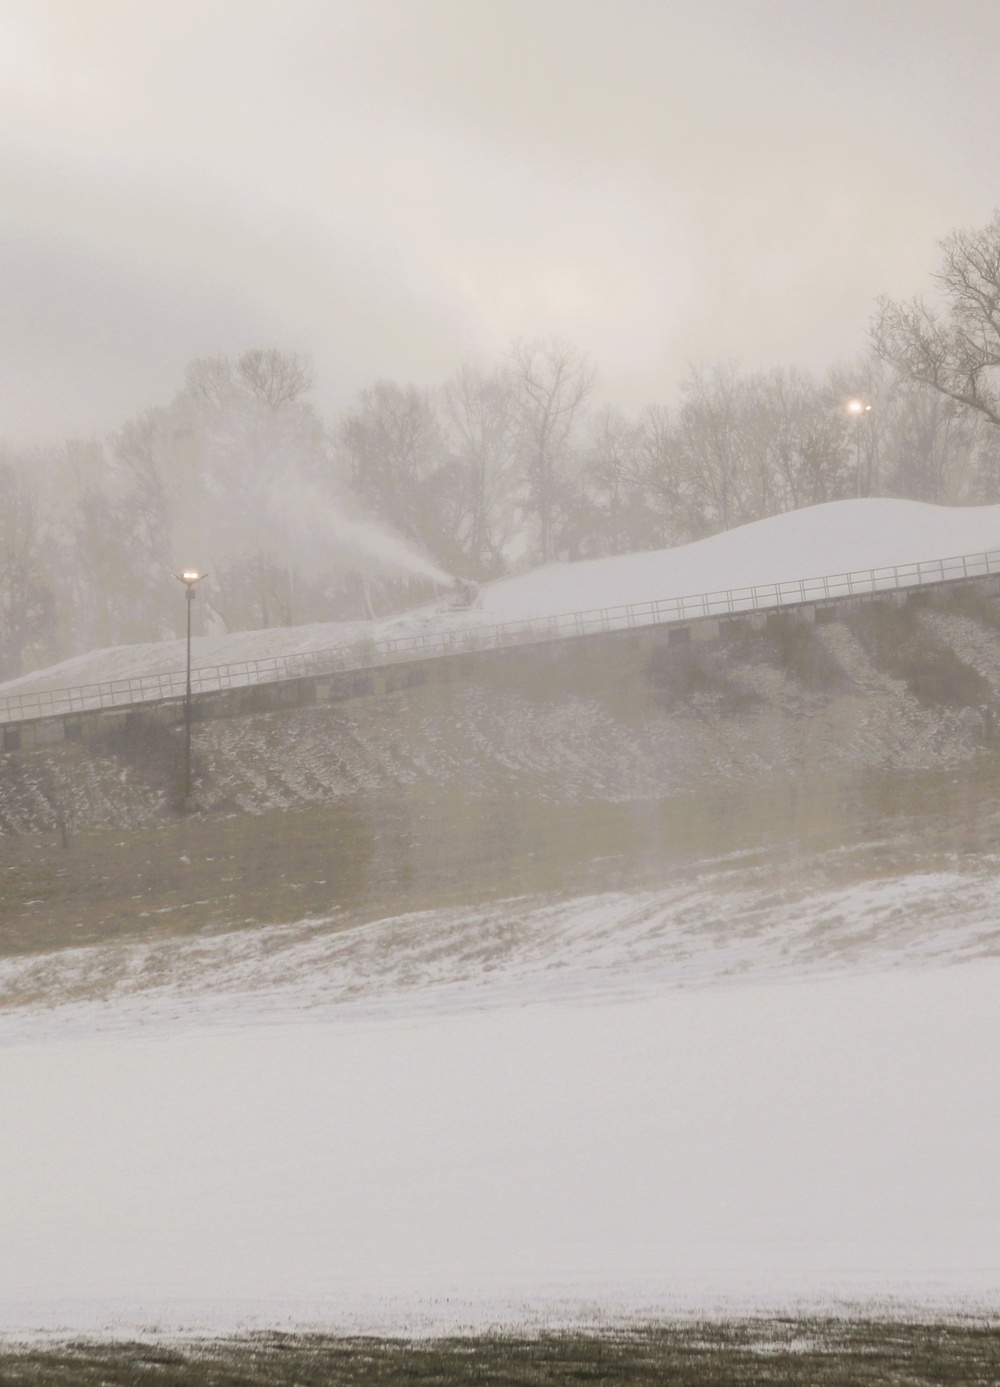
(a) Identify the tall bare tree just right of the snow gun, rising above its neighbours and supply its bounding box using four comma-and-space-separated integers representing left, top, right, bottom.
508, 337, 594, 563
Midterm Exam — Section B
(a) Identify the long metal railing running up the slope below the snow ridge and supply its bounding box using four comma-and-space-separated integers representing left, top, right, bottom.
0, 549, 1000, 724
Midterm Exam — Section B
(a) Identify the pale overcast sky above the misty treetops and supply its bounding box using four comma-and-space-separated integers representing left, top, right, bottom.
0, 0, 1000, 440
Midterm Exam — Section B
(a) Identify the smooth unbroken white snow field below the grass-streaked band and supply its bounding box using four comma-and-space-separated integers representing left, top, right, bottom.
0, 963, 1000, 1327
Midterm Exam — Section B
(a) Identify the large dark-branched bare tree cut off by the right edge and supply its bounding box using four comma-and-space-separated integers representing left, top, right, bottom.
871, 211, 1000, 424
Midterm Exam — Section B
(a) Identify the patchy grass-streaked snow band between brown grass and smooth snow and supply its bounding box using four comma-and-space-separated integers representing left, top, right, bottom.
0, 850, 1000, 1036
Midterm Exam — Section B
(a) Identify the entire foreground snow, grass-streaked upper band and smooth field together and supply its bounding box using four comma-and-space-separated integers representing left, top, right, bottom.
0, 859, 1000, 1334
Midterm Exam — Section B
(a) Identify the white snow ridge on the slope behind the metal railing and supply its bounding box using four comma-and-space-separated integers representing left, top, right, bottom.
0, 498, 1000, 698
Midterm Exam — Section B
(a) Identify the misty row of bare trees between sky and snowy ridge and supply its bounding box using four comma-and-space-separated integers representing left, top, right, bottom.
0, 214, 1000, 678
